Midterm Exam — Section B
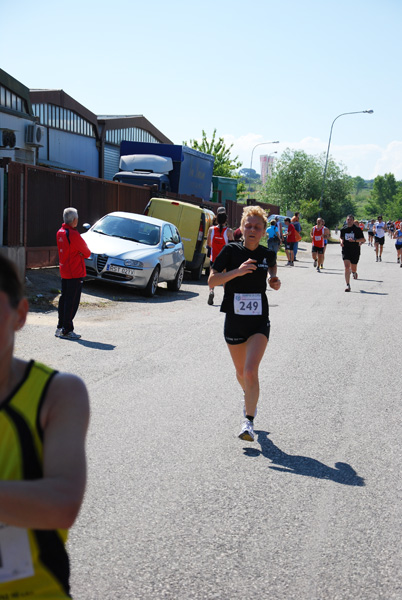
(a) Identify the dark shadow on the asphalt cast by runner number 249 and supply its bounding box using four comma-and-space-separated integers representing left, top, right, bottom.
244, 431, 365, 487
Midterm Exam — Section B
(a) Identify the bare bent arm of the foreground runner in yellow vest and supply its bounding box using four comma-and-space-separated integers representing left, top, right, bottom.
0, 374, 89, 529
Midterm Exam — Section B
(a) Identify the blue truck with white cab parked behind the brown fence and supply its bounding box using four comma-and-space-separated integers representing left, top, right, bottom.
113, 141, 215, 201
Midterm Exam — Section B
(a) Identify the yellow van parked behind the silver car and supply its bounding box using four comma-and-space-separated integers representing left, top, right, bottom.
144, 198, 215, 280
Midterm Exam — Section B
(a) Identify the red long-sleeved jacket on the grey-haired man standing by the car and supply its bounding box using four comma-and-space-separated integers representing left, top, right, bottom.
57, 223, 91, 279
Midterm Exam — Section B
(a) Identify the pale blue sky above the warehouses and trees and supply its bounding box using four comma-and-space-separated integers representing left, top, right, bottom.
0, 0, 402, 180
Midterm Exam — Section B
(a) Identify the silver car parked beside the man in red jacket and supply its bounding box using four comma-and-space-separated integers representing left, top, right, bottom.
82, 212, 185, 297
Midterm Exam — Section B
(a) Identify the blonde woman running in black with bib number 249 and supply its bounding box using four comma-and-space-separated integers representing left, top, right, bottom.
208, 206, 281, 442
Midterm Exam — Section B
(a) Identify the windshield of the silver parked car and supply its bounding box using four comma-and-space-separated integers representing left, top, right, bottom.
92, 215, 161, 246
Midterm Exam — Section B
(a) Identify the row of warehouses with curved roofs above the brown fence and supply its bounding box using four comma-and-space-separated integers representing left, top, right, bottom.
0, 69, 172, 180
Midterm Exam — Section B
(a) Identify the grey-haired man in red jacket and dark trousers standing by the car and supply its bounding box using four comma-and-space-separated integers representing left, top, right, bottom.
55, 207, 91, 340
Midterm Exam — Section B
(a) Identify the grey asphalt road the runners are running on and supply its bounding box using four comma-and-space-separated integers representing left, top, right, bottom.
16, 238, 402, 600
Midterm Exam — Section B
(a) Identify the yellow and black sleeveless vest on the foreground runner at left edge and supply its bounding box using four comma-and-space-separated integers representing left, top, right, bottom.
0, 361, 70, 600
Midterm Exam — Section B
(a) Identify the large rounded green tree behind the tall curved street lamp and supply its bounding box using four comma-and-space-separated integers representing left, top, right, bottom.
262, 148, 354, 227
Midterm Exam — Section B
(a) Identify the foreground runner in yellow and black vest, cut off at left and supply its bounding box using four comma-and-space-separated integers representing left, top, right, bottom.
0, 256, 89, 600
